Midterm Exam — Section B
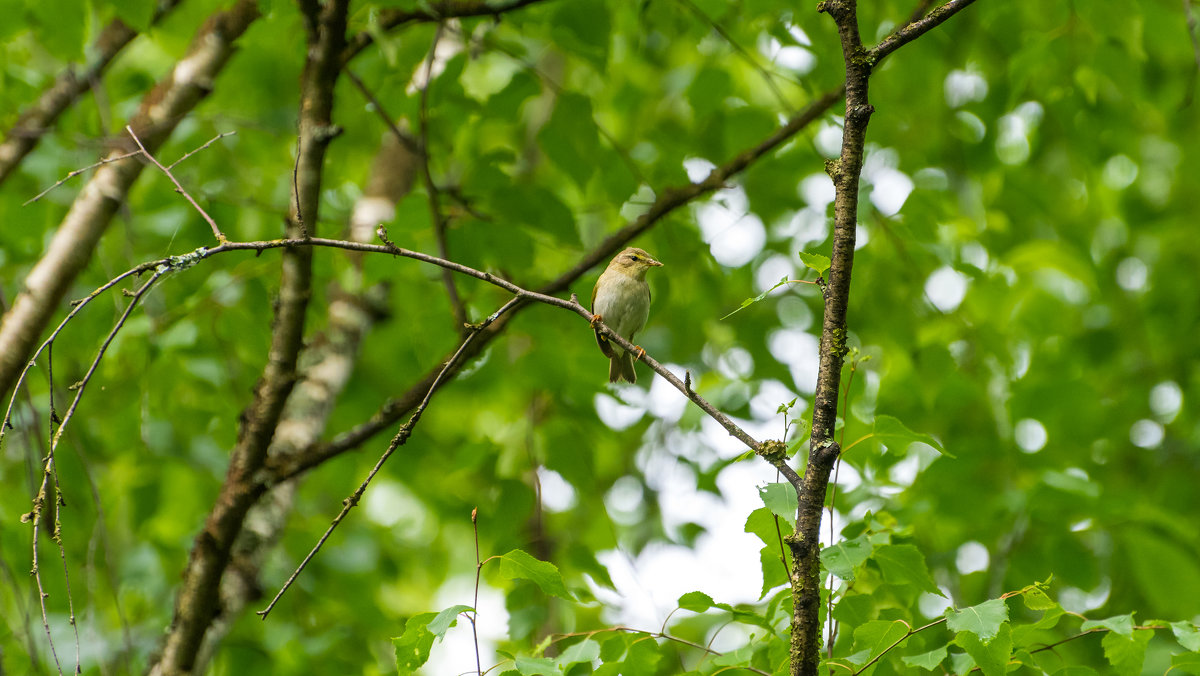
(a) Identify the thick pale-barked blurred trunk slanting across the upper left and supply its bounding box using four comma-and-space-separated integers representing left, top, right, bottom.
0, 0, 259, 408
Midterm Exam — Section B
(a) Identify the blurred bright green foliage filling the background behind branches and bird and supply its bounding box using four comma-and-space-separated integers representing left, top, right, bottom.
0, 0, 1200, 676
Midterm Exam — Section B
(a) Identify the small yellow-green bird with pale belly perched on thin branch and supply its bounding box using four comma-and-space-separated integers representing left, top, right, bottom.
592, 247, 662, 383
